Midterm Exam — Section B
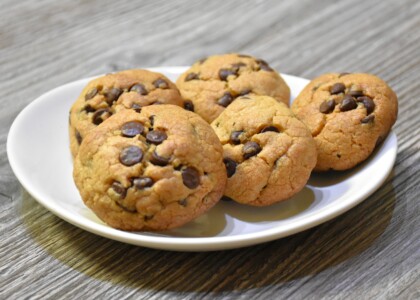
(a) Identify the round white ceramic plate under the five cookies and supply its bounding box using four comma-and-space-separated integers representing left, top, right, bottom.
7, 67, 397, 251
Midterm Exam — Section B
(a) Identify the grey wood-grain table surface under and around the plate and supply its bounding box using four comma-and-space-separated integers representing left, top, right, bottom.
0, 0, 420, 299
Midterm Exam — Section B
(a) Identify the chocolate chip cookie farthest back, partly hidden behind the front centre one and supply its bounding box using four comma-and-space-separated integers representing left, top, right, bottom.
176, 54, 290, 123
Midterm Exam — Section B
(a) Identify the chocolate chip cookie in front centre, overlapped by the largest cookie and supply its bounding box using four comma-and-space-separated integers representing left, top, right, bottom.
211, 95, 316, 206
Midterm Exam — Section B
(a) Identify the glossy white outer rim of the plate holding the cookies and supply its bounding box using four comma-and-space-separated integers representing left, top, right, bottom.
6, 66, 398, 251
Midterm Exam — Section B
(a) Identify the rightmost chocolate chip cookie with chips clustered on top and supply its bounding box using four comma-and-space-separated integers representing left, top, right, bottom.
292, 73, 398, 171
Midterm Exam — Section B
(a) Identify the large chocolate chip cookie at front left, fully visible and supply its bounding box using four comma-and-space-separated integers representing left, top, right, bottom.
73, 104, 226, 231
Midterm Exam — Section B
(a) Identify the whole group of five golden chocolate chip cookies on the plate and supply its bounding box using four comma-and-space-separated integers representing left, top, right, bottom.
70, 54, 397, 231
